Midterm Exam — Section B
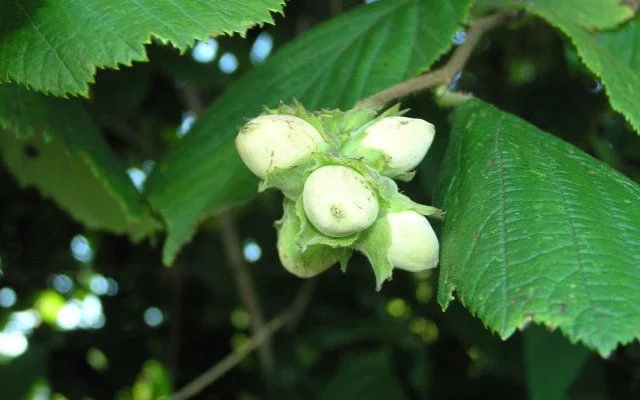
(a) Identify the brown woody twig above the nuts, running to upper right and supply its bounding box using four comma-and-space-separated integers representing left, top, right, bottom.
357, 11, 508, 107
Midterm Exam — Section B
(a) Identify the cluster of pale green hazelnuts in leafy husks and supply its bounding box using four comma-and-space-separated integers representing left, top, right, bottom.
236, 104, 440, 288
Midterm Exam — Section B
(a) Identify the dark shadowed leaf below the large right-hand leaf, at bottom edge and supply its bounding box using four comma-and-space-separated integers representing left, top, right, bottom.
524, 326, 589, 400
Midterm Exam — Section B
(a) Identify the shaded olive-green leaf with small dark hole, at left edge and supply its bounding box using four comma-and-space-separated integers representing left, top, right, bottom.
0, 84, 159, 240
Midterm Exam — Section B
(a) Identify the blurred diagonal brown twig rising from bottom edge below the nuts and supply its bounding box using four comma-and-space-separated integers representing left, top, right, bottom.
171, 281, 313, 400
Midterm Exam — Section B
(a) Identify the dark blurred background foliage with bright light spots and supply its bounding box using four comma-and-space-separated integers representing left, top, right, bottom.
0, 0, 640, 400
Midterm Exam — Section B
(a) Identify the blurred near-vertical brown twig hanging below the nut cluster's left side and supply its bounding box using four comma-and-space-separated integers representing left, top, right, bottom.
220, 211, 274, 382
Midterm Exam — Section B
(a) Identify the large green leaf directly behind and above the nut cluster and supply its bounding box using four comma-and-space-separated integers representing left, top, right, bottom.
147, 0, 472, 264
